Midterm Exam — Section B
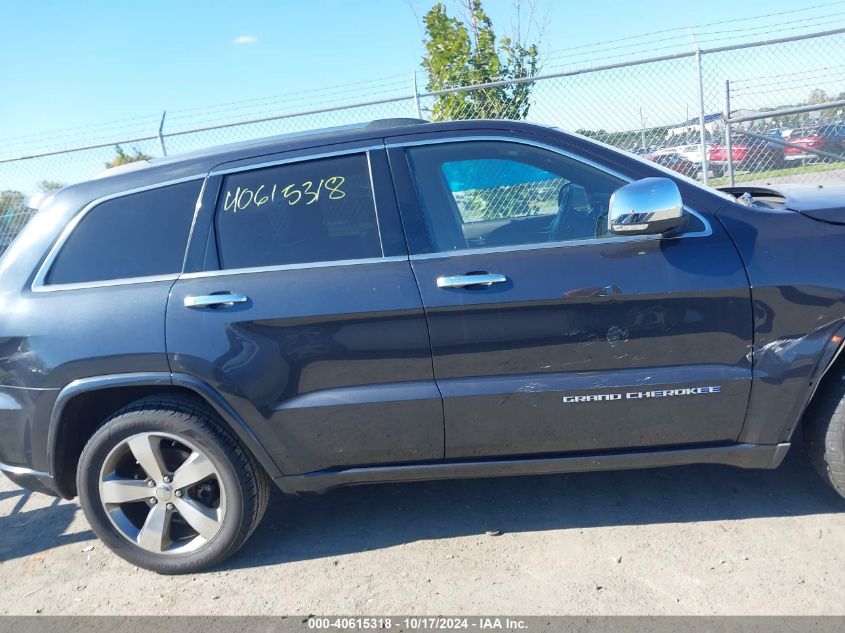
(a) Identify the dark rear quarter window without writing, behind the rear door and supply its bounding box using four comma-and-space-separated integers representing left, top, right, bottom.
47, 180, 202, 284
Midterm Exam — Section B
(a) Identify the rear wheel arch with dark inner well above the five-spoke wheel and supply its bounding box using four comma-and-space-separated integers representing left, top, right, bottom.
47, 372, 282, 499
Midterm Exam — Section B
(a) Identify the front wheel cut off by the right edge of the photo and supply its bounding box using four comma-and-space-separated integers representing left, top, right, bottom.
804, 368, 845, 497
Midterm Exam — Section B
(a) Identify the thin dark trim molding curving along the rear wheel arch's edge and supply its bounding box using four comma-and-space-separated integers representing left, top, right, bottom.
47, 372, 282, 477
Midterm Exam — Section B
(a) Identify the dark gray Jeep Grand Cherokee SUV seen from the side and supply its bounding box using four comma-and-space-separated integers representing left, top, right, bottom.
0, 120, 845, 573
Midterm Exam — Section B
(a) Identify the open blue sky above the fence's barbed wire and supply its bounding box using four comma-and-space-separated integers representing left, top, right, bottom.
0, 0, 832, 147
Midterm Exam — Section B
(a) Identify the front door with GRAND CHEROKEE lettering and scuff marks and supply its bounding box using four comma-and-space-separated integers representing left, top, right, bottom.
390, 135, 752, 458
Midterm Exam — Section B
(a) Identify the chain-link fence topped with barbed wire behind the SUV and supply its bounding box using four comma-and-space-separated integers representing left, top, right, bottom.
0, 27, 845, 251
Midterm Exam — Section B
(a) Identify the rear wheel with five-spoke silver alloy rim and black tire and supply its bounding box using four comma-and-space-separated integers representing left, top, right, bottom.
77, 395, 270, 574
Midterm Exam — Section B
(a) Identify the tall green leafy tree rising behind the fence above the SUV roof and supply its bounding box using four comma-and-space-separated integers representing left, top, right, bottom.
423, 0, 539, 121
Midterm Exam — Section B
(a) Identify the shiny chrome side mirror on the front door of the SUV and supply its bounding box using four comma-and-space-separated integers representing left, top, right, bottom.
607, 178, 685, 235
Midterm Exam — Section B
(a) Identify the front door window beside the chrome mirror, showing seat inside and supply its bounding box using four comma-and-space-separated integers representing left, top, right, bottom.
408, 141, 625, 251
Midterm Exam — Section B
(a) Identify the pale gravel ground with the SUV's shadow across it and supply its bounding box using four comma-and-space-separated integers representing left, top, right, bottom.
0, 450, 845, 615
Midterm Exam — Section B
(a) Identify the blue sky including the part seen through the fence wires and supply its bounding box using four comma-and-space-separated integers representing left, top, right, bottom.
0, 0, 845, 192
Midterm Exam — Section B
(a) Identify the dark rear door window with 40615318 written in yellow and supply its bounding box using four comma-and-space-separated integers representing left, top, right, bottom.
216, 154, 382, 268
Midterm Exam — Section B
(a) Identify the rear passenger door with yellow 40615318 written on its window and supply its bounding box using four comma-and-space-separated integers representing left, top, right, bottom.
167, 144, 443, 474
